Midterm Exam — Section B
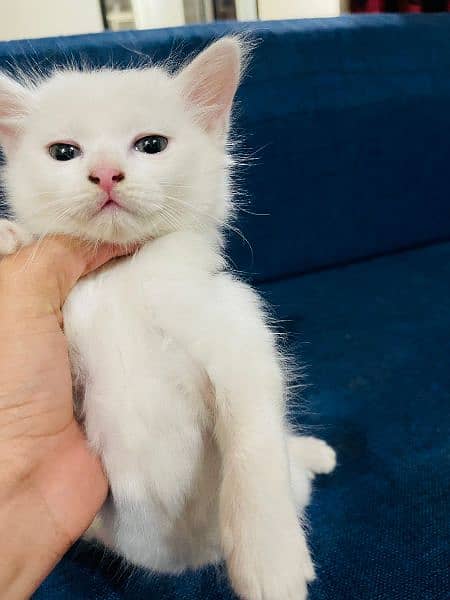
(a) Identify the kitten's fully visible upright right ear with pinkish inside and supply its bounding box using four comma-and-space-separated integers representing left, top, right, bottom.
177, 37, 247, 137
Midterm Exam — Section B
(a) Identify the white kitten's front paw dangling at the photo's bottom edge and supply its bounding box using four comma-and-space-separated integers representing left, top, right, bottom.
227, 524, 315, 600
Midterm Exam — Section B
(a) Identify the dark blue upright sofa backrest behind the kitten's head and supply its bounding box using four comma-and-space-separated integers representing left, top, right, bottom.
0, 15, 450, 281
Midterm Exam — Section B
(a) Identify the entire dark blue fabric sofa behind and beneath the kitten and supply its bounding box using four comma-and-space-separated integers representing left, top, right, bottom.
0, 15, 450, 600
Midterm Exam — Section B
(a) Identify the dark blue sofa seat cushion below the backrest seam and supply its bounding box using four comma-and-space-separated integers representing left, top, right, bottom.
34, 244, 450, 600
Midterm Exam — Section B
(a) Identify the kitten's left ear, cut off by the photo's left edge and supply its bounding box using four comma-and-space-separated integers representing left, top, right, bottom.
0, 73, 31, 150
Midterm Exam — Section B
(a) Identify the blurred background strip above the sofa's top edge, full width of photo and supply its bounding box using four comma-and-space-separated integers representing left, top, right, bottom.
0, 0, 450, 40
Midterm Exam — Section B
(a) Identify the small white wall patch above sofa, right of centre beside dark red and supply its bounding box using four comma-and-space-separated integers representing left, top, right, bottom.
259, 0, 341, 19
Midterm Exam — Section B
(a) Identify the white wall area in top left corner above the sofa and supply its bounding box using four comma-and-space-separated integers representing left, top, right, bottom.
0, 0, 103, 40
